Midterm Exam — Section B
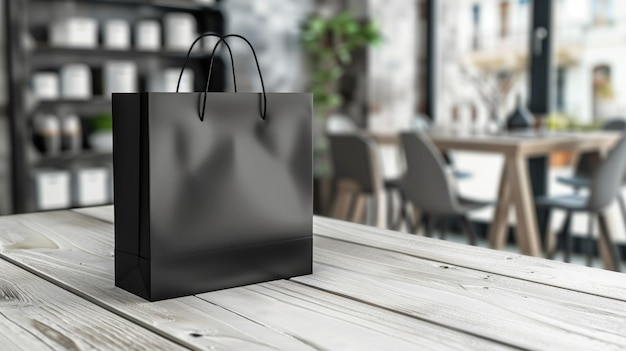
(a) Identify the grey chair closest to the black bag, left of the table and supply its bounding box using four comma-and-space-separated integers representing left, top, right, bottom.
328, 133, 387, 228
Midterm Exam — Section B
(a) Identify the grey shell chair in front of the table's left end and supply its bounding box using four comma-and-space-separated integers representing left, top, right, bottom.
400, 132, 490, 245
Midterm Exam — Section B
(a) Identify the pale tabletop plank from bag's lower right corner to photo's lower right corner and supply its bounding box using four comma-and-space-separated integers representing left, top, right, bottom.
293, 238, 626, 350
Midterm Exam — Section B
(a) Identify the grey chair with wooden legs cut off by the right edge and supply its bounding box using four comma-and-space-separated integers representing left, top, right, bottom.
536, 136, 626, 271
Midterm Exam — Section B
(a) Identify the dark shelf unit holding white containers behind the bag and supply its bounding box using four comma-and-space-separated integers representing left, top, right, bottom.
5, 0, 225, 213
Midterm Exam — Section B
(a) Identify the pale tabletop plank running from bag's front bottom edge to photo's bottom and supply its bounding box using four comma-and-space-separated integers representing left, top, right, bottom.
199, 280, 510, 350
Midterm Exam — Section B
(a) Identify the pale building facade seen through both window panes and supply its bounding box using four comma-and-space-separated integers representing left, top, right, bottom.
437, 0, 626, 129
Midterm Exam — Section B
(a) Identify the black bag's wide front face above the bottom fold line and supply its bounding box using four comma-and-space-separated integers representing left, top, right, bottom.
142, 93, 313, 258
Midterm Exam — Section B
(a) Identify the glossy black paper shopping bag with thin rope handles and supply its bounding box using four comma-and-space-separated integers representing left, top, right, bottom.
113, 34, 313, 301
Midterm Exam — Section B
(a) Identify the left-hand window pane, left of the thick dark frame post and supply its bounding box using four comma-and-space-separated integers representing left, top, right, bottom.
436, 0, 530, 130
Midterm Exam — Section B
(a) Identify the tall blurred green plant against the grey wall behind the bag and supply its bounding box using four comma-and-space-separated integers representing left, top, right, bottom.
301, 11, 381, 175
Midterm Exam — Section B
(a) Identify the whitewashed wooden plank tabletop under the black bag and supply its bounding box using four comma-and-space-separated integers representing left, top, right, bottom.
0, 207, 626, 351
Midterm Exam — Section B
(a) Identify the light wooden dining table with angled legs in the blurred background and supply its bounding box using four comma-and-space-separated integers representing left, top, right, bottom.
372, 130, 622, 268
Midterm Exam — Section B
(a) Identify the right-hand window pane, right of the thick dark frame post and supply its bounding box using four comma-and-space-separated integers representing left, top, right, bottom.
553, 0, 626, 126
